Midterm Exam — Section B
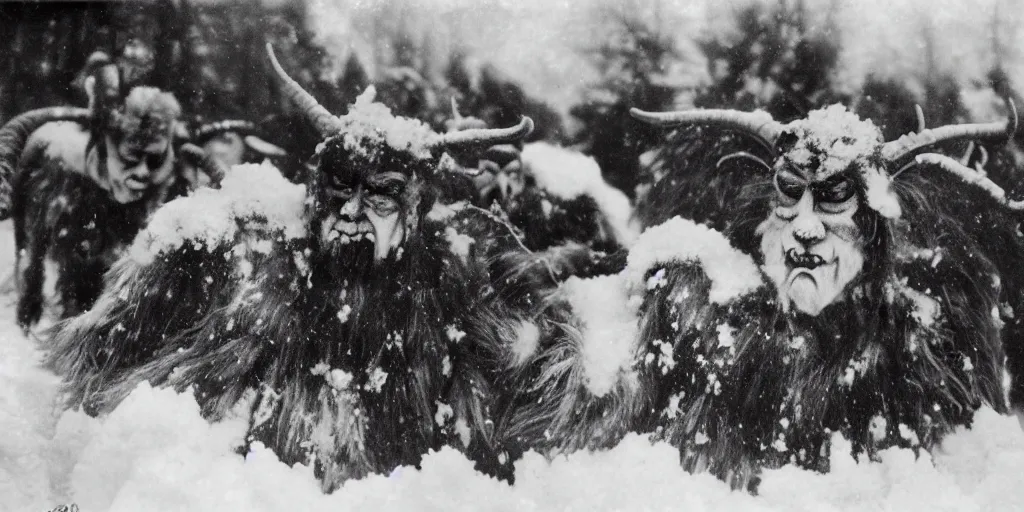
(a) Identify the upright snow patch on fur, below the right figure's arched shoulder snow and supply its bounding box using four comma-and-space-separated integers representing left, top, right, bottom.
559, 274, 639, 396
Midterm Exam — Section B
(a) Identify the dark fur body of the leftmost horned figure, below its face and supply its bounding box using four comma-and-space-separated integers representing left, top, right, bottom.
12, 134, 186, 329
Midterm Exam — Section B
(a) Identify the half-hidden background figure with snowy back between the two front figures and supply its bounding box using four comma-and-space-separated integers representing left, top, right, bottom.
449, 100, 635, 252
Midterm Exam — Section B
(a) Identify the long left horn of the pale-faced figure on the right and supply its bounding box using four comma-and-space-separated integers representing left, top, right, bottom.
630, 104, 782, 151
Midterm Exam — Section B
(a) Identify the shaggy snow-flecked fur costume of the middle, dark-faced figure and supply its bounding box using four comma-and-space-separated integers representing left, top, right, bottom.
41, 138, 589, 492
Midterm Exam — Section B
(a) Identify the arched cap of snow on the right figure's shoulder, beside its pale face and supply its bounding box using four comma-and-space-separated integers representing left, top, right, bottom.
626, 217, 762, 304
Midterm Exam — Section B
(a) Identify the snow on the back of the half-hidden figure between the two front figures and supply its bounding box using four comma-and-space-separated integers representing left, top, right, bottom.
522, 142, 637, 246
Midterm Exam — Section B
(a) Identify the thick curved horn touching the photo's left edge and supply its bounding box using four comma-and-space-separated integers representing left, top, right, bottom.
0, 106, 91, 220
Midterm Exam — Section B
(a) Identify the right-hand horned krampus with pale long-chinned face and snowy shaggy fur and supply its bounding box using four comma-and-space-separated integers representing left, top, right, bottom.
513, 101, 1024, 487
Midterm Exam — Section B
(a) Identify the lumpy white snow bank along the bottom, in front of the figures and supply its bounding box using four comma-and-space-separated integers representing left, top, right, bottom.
34, 385, 1024, 512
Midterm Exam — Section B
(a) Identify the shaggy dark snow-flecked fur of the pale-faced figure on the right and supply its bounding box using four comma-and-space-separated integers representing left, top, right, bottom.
509, 125, 1024, 489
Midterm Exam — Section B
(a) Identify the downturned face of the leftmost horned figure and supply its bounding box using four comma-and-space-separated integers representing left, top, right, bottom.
105, 136, 174, 204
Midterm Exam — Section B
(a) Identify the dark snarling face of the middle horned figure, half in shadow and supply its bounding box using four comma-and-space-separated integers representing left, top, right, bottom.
321, 169, 409, 261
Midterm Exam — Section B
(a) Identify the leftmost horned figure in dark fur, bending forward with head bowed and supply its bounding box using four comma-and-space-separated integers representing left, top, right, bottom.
0, 65, 221, 329
